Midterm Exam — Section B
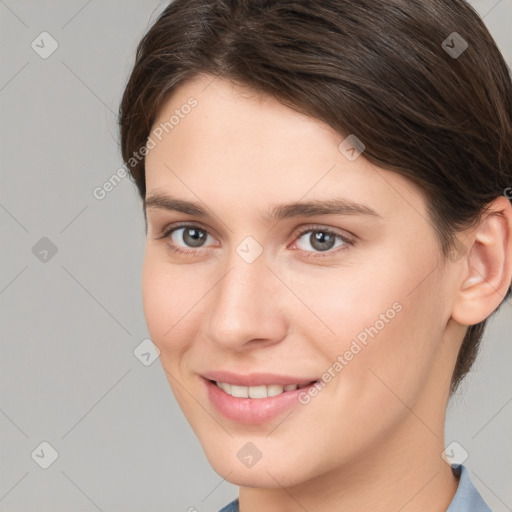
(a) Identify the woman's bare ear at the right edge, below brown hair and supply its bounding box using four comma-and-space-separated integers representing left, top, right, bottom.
452, 196, 512, 325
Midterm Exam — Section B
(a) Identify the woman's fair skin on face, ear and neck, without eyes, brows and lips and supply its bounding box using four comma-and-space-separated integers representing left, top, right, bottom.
142, 72, 512, 512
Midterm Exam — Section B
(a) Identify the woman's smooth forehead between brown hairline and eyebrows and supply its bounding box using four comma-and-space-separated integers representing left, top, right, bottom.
146, 75, 423, 224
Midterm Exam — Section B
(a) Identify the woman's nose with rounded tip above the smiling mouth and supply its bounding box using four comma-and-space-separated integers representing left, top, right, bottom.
207, 253, 290, 351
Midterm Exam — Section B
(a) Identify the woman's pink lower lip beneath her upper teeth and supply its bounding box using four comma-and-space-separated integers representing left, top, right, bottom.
202, 377, 314, 425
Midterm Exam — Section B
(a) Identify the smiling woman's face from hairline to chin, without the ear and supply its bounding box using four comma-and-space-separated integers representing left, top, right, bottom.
142, 76, 462, 487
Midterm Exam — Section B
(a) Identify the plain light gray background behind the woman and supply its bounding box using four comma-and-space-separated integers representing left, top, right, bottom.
0, 0, 512, 512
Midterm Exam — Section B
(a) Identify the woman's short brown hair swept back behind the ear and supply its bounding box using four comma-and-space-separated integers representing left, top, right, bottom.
119, 0, 512, 393
